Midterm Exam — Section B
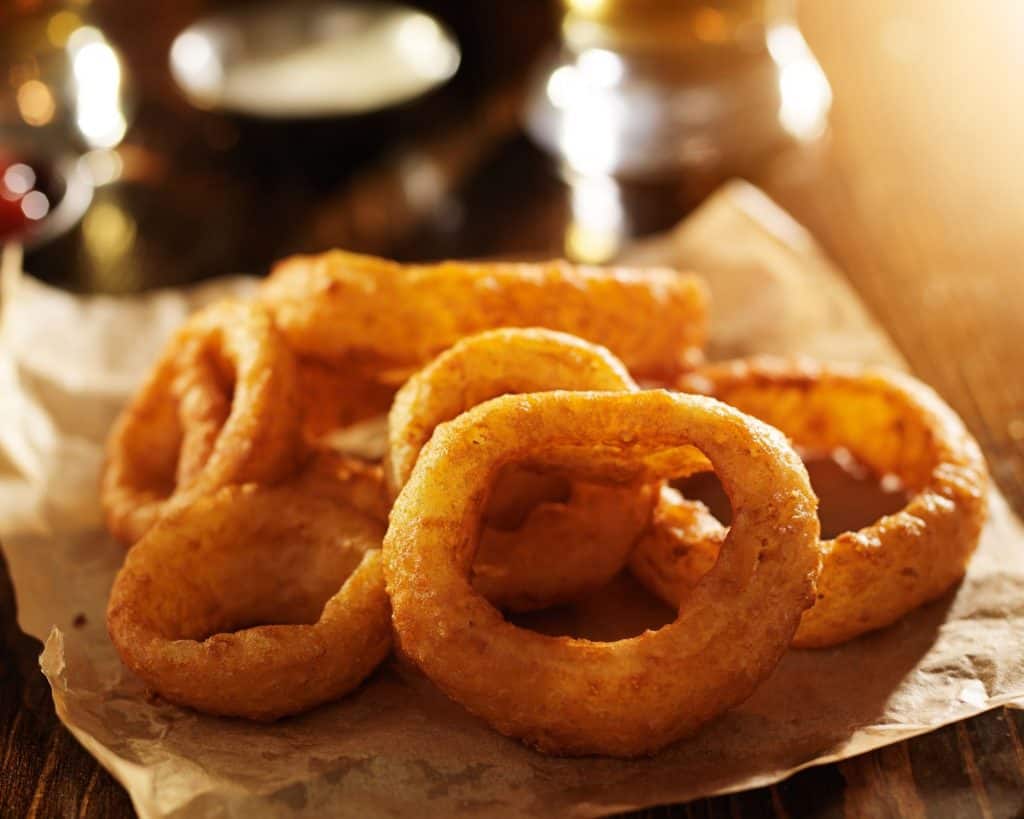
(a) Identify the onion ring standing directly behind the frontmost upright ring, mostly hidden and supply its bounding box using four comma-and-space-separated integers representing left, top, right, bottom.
385, 329, 654, 611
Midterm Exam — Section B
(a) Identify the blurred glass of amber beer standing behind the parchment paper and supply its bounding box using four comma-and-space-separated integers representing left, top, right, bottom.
525, 0, 831, 261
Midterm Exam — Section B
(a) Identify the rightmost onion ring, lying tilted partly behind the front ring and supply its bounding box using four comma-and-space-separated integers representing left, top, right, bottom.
630, 357, 988, 648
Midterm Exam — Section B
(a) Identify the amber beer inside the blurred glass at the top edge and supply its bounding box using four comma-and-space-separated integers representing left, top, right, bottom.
562, 0, 780, 50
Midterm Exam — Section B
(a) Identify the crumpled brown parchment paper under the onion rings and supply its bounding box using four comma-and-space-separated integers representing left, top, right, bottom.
0, 183, 1024, 819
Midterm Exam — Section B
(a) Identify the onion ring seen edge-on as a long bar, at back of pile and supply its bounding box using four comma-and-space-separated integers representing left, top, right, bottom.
261, 251, 708, 379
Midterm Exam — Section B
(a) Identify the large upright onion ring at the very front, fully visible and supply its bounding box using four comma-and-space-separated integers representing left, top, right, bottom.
384, 390, 819, 757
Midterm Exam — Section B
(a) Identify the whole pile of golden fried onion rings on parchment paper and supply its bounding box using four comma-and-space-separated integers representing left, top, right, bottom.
101, 251, 988, 757
